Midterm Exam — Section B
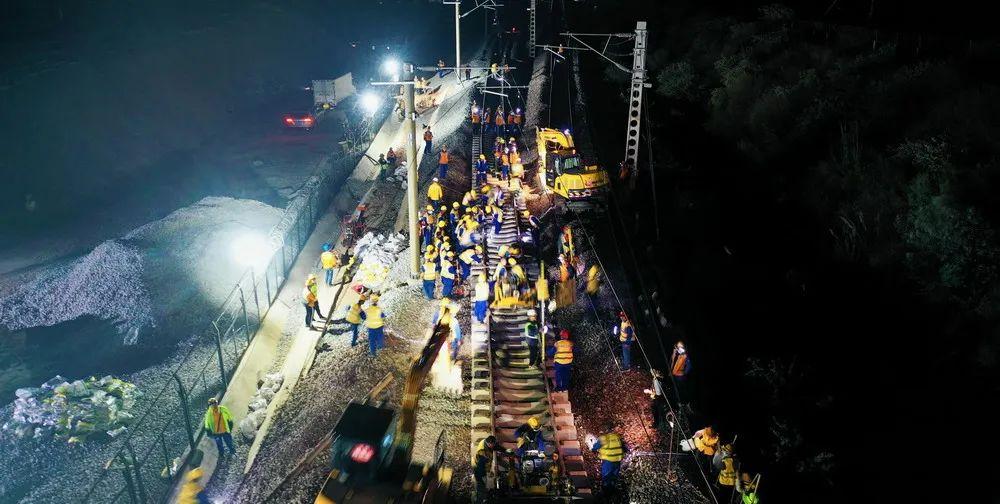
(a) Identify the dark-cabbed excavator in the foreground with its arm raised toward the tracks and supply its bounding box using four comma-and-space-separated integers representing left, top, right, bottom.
315, 323, 452, 504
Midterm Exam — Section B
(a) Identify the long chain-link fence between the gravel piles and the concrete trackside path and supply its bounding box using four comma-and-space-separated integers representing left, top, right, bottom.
80, 104, 388, 503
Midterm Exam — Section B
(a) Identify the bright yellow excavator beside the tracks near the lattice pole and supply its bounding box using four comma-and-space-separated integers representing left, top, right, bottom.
535, 128, 608, 201
